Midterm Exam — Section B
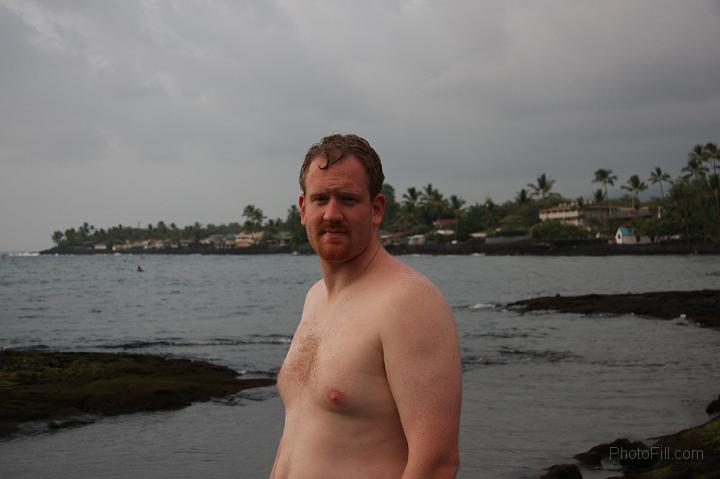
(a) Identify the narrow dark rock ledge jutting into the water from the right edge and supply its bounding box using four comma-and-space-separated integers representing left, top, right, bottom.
507, 289, 720, 328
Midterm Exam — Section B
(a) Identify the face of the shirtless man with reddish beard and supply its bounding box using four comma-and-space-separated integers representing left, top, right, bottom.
299, 156, 385, 263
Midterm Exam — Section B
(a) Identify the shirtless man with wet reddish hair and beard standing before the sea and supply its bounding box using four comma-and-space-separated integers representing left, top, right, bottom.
270, 135, 461, 479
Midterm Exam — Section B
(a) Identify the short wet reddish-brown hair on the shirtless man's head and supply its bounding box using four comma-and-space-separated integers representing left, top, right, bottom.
300, 133, 385, 200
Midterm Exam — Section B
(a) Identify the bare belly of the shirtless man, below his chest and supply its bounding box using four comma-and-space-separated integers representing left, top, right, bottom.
271, 410, 407, 479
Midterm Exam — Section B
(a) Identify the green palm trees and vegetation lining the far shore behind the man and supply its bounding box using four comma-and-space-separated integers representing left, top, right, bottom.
52, 143, 720, 250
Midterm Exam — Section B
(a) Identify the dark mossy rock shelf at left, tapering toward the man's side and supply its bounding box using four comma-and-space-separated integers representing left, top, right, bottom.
0, 349, 275, 437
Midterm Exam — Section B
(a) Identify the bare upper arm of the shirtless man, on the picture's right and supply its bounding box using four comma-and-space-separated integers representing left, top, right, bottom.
380, 278, 462, 479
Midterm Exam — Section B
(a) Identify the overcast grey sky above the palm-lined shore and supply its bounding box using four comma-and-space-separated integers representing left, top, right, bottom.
0, 0, 720, 251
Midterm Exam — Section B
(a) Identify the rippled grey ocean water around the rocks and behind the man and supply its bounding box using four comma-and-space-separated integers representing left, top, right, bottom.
0, 255, 720, 479
